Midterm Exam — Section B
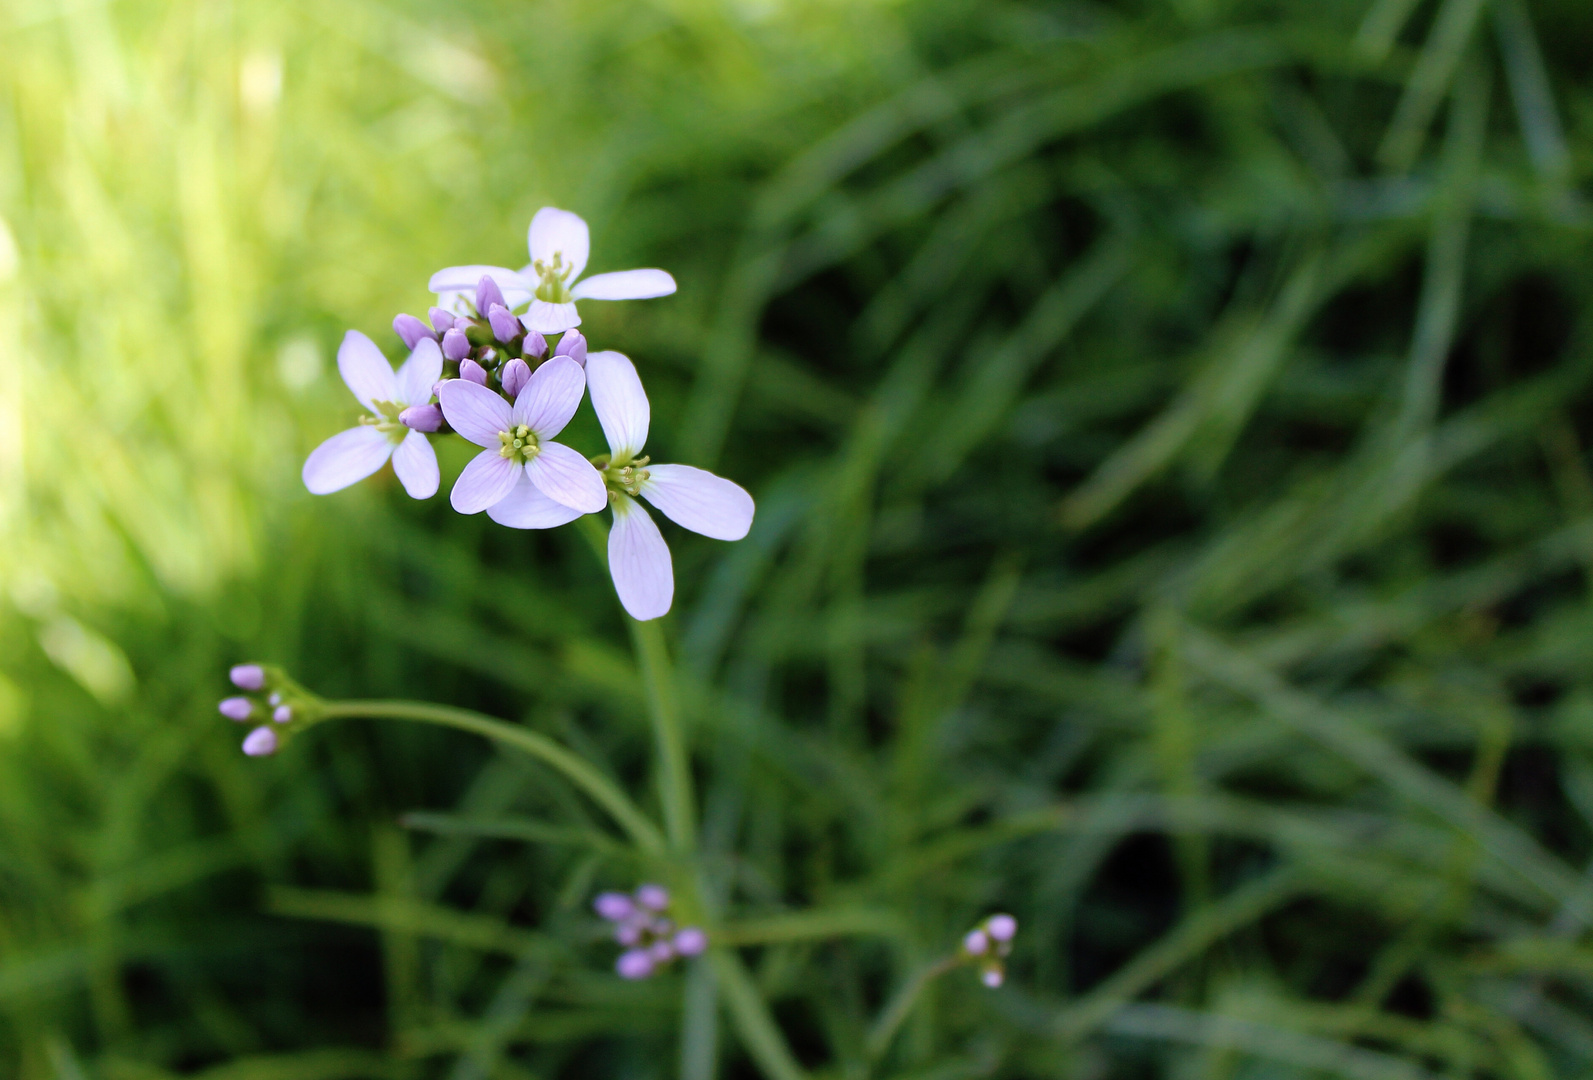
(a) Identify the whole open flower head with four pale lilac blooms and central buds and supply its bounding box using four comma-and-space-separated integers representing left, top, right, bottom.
302, 207, 753, 621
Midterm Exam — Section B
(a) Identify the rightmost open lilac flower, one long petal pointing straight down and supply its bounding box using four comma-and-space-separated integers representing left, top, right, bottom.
589, 352, 753, 620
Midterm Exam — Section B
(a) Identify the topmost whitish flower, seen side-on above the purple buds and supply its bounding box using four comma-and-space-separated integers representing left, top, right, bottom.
430, 205, 675, 335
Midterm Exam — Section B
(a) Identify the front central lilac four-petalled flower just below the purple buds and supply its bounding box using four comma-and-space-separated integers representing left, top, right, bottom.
441, 357, 609, 529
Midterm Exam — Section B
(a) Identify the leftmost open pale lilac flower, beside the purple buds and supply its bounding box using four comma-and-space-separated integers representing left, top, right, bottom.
304, 330, 443, 499
